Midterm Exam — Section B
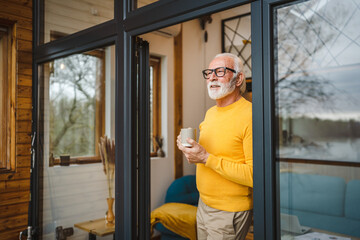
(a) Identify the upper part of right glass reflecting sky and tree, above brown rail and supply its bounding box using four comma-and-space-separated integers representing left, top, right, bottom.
275, 0, 360, 162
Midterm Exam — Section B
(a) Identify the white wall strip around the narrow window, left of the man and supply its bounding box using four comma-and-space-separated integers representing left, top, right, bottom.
141, 33, 175, 210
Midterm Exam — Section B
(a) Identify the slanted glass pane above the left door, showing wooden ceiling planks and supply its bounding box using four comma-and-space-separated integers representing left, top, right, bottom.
41, 0, 114, 43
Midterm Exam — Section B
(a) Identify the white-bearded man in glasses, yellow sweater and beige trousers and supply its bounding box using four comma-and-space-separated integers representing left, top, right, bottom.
177, 53, 253, 240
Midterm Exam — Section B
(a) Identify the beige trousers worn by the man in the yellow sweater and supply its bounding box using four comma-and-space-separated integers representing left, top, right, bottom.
196, 199, 252, 240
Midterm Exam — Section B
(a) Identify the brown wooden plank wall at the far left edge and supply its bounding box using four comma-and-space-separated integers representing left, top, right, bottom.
0, 0, 32, 240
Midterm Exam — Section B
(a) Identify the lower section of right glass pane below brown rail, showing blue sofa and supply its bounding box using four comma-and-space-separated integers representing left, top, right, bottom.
278, 162, 360, 240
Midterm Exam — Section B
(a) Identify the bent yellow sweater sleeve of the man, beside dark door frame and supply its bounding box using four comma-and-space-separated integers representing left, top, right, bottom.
205, 124, 253, 188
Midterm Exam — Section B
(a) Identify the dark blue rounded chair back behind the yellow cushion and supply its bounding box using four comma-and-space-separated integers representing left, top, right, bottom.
165, 175, 199, 206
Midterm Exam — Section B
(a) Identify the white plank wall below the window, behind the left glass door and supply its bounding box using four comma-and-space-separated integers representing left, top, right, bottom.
42, 164, 110, 240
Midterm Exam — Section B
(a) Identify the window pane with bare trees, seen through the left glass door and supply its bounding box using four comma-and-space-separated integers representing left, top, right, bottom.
49, 50, 103, 158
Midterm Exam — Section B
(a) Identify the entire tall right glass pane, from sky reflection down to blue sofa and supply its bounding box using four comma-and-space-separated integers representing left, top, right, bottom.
274, 0, 360, 239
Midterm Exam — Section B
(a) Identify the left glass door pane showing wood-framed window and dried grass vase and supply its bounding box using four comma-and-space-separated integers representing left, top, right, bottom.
37, 46, 115, 240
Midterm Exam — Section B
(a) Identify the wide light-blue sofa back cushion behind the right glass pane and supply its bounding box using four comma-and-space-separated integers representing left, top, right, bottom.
280, 172, 346, 217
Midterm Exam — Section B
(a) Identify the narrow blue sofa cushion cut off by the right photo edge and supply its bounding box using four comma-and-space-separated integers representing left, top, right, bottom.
345, 180, 360, 221
